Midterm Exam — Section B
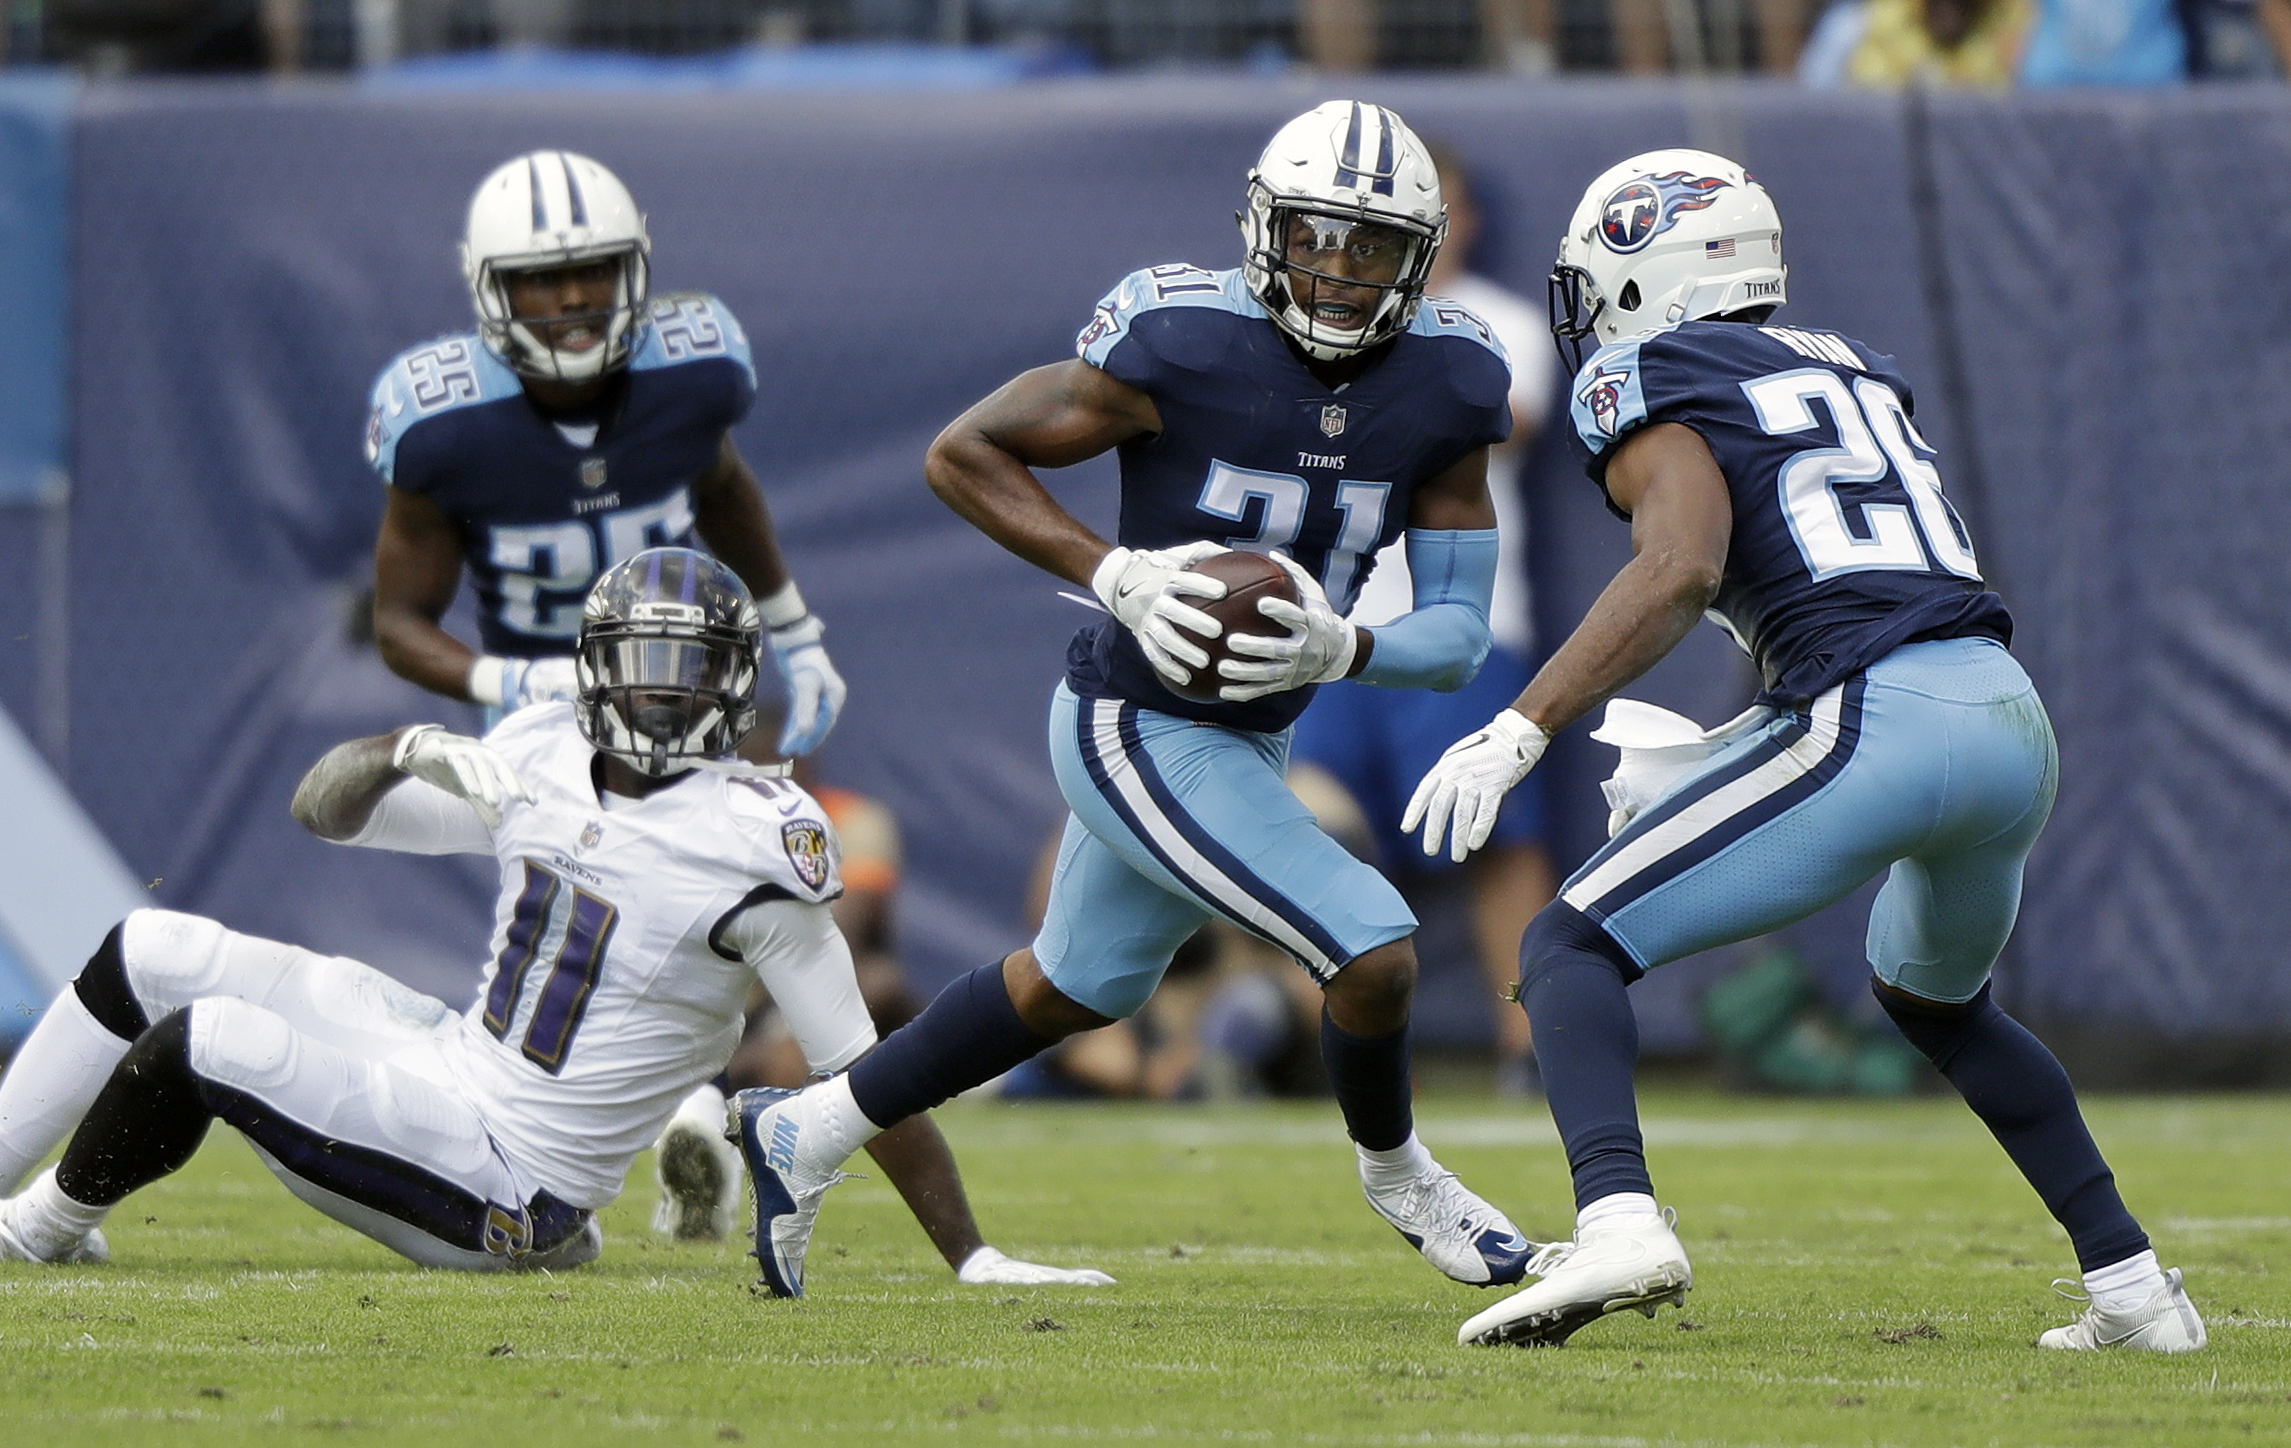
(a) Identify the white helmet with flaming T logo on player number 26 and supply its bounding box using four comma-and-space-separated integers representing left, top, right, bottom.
1551, 149, 1789, 369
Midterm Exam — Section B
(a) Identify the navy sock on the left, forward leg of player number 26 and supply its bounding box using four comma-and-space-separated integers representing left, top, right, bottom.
1519, 900, 1654, 1207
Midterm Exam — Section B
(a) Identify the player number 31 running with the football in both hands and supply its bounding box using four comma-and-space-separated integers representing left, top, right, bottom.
733, 101, 1530, 1285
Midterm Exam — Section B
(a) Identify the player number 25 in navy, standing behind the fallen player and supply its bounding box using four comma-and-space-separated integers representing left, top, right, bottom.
367, 151, 843, 756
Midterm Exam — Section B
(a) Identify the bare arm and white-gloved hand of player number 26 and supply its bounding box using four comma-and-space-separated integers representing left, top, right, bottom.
1400, 422, 1734, 859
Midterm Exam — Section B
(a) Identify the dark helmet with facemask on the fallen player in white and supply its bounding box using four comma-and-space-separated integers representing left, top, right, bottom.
573, 548, 763, 779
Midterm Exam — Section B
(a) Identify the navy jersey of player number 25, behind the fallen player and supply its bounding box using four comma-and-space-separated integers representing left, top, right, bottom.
367, 293, 756, 658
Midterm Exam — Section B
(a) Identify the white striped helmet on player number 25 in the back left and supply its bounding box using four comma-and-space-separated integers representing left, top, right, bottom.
460, 151, 653, 383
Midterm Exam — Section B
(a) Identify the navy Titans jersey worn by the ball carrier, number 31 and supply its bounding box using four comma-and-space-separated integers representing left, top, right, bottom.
1065, 266, 1512, 733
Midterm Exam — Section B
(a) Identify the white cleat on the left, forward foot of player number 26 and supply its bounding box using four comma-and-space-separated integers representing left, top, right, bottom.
1455, 1214, 1695, 1347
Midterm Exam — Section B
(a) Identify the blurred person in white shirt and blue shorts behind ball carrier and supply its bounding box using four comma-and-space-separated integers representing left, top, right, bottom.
1294, 142, 1556, 1088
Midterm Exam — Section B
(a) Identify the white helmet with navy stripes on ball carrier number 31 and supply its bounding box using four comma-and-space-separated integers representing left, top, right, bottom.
1237, 101, 1448, 362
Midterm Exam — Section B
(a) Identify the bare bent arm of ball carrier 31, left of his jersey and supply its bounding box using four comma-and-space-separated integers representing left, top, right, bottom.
923, 357, 1162, 584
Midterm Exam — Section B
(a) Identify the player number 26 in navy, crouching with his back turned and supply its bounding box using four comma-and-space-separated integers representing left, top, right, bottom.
1402, 151, 2204, 1352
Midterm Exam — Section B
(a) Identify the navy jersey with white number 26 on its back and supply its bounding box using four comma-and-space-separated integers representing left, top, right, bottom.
1572, 321, 2011, 708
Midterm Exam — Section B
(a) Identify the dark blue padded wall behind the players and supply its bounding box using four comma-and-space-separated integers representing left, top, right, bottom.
0, 80, 2291, 1076
